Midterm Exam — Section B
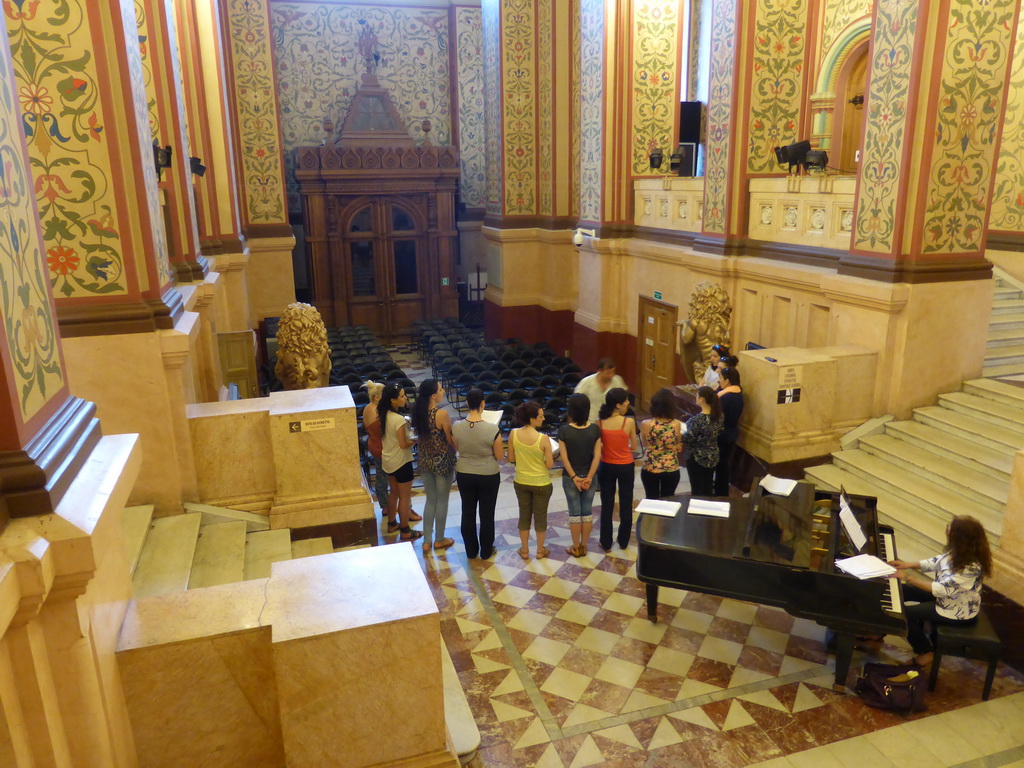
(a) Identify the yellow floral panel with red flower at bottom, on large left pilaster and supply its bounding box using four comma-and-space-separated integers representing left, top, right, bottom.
3, 0, 127, 298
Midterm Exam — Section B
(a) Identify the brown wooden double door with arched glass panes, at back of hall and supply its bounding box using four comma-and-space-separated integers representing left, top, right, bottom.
333, 197, 429, 341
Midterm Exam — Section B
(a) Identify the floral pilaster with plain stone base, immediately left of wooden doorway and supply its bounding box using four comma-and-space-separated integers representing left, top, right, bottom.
219, 0, 295, 326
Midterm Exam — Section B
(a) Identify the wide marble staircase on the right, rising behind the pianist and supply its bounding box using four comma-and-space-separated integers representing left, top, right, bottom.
806, 379, 1024, 559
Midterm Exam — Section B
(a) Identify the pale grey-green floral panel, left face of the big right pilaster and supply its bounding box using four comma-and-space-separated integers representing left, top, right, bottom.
851, 0, 919, 253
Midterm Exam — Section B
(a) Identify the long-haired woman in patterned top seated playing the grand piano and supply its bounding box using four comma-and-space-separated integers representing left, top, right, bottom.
889, 515, 992, 667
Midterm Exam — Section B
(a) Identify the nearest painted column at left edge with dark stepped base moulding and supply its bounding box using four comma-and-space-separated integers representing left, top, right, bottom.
0, 30, 99, 530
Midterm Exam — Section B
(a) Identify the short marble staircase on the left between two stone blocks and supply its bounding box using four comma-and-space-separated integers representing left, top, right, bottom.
124, 504, 334, 598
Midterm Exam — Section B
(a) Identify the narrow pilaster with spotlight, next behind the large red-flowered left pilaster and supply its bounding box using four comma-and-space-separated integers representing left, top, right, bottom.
135, 0, 210, 283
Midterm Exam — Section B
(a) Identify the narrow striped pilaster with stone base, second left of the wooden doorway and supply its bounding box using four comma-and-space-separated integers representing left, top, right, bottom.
173, 0, 251, 332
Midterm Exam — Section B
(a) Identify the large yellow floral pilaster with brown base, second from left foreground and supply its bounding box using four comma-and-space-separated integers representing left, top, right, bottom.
4, 0, 181, 337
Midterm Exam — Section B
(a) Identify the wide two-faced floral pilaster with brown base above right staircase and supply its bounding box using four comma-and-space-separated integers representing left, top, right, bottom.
840, 0, 1019, 283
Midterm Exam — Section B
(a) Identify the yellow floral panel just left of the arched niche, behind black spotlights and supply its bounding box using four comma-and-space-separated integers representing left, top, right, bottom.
746, 0, 808, 173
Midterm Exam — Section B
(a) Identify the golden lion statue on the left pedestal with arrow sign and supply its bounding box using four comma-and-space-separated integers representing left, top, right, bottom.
273, 301, 331, 389
